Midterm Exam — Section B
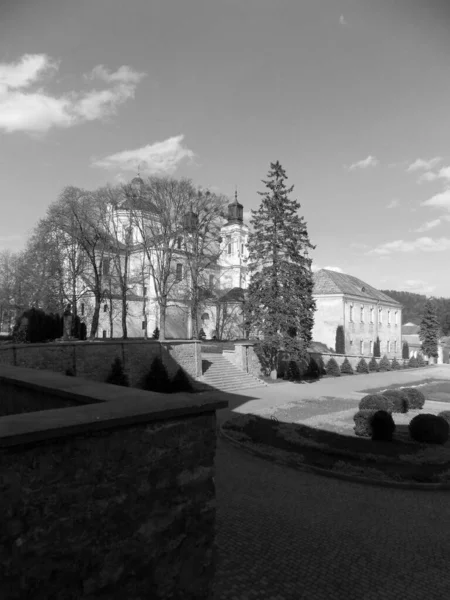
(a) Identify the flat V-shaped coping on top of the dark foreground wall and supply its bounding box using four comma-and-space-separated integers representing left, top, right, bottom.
0, 365, 228, 448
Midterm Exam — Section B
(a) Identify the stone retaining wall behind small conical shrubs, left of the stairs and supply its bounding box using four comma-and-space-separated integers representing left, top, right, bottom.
0, 340, 202, 386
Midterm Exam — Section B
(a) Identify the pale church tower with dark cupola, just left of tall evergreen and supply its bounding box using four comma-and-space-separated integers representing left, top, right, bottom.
219, 191, 249, 290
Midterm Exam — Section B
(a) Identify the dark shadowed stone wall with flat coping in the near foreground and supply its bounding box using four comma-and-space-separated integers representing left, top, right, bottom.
0, 366, 227, 600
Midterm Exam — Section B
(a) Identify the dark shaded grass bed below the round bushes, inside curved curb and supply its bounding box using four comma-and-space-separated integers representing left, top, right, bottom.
223, 415, 450, 483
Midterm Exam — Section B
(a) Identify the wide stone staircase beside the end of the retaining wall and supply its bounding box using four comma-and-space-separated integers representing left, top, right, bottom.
201, 352, 267, 392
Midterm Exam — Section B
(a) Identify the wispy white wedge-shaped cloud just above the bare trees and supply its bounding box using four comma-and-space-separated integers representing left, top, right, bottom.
92, 135, 195, 174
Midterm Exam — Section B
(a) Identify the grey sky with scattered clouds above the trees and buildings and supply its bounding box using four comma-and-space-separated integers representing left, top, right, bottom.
0, 0, 450, 296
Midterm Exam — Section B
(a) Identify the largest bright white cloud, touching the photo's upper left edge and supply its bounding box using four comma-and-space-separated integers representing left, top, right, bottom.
0, 54, 144, 133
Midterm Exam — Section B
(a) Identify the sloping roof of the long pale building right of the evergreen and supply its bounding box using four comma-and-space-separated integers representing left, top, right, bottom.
313, 269, 401, 306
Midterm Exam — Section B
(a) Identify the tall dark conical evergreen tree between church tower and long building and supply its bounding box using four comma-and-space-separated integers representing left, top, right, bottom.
247, 161, 315, 374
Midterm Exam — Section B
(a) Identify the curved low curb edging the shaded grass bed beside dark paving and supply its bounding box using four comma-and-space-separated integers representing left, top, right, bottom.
218, 425, 450, 492
